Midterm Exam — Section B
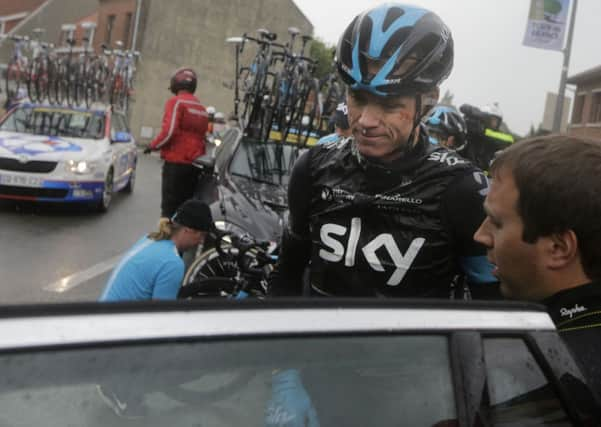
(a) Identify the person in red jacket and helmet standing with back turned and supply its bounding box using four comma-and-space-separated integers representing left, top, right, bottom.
147, 68, 208, 218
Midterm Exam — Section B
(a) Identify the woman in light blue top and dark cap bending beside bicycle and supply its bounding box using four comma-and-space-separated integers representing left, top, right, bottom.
100, 200, 214, 301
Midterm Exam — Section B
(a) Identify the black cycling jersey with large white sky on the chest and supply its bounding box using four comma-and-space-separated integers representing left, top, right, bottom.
272, 131, 496, 297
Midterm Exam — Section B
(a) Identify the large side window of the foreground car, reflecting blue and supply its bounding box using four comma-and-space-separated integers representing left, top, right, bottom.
0, 335, 456, 426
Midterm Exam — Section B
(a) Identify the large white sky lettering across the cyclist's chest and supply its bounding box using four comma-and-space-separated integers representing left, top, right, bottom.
319, 218, 426, 286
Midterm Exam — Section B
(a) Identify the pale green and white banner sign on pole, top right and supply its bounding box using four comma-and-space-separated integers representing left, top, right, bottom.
524, 0, 570, 50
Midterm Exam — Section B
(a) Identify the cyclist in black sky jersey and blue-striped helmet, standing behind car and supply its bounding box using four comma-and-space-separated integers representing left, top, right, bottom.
271, 4, 498, 297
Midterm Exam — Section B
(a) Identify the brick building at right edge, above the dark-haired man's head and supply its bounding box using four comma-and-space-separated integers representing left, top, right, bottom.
568, 66, 601, 140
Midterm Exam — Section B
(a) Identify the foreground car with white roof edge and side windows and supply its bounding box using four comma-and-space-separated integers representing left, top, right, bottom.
0, 300, 598, 427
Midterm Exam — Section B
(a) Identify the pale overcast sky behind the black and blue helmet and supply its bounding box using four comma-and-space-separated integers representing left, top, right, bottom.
294, 0, 601, 134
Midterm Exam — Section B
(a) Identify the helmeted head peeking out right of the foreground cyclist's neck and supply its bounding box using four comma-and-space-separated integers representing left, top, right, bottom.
424, 105, 467, 152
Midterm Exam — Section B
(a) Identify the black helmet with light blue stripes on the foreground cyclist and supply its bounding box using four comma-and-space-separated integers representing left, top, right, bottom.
336, 4, 453, 96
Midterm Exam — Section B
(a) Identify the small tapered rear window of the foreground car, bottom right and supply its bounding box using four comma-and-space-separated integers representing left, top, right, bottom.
484, 338, 572, 427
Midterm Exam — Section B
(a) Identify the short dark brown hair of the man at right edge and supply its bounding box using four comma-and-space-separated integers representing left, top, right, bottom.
490, 135, 601, 280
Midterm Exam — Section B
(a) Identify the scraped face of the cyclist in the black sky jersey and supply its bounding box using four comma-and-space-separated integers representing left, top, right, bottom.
347, 90, 415, 161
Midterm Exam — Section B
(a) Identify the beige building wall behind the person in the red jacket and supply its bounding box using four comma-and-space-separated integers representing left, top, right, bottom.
131, 0, 313, 143
